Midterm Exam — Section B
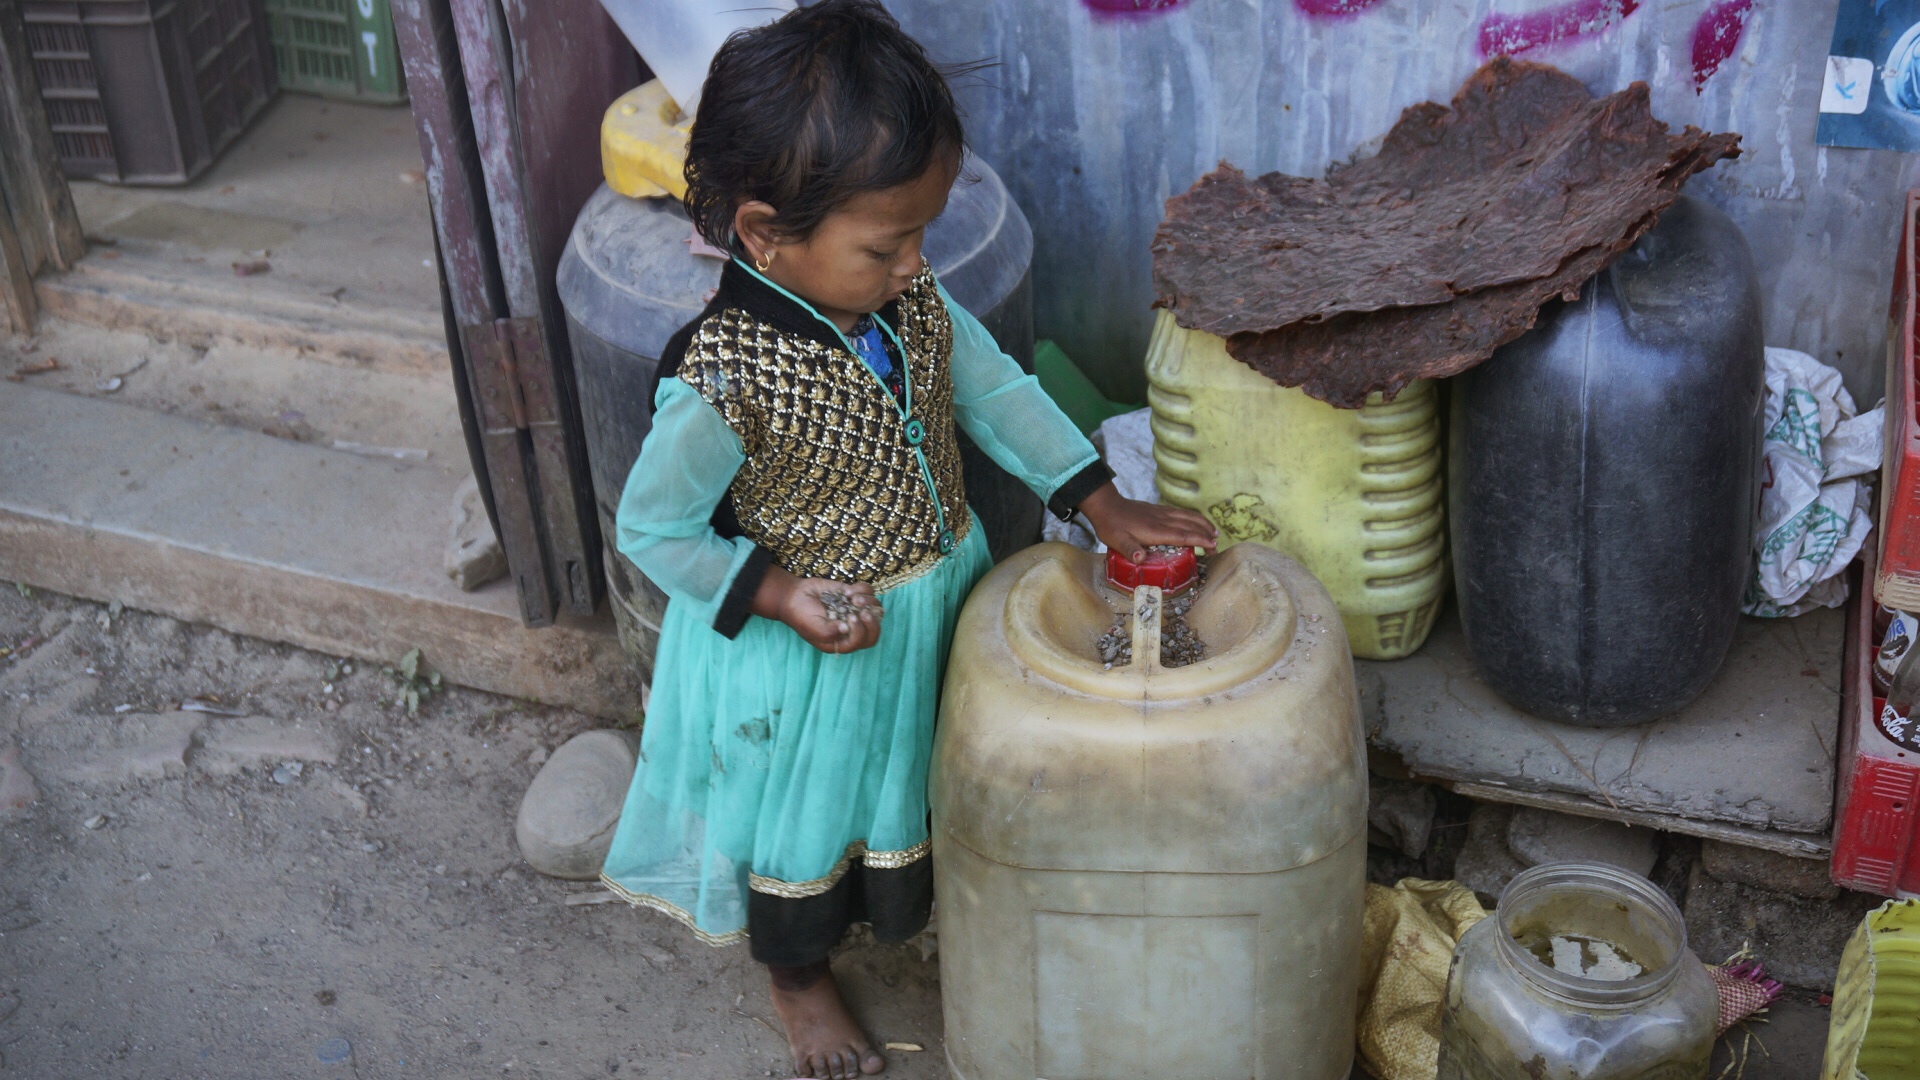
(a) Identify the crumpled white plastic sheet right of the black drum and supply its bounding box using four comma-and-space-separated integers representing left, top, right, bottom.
1741, 348, 1882, 617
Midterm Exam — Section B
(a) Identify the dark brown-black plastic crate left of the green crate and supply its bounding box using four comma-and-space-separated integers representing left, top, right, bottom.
21, 0, 276, 184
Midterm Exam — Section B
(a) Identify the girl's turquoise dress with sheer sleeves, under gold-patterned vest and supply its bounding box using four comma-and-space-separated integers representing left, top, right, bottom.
603, 261, 1108, 963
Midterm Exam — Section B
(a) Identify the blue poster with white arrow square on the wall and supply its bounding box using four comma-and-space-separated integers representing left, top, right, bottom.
1816, 0, 1920, 150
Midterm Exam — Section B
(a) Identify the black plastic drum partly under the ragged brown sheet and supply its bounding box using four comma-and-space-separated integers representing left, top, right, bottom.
1448, 196, 1764, 726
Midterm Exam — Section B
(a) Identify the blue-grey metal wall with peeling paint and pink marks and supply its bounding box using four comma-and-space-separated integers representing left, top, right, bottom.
887, 0, 1920, 404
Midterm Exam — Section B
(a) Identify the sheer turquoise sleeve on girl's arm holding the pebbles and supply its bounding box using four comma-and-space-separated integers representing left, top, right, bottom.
614, 379, 766, 638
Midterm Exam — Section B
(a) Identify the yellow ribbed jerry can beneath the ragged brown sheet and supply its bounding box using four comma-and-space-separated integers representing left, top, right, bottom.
1146, 311, 1446, 659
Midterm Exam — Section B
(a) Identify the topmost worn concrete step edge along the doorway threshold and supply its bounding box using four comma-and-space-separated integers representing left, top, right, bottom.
35, 246, 447, 375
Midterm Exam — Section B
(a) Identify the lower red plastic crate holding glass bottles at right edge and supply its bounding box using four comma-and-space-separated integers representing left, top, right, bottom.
1832, 541, 1920, 896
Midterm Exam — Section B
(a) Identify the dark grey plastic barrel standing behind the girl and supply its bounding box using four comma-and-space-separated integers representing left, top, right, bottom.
559, 158, 1044, 682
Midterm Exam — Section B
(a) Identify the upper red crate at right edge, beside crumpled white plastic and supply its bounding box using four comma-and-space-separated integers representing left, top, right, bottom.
1874, 190, 1920, 611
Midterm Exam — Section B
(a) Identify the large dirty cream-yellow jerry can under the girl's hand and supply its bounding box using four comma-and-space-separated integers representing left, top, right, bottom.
931, 544, 1367, 1080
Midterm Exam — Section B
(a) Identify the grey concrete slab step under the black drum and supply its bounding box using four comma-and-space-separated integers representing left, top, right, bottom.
1354, 609, 1845, 859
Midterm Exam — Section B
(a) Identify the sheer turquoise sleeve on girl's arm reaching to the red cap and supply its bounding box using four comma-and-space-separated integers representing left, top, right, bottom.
941, 286, 1114, 519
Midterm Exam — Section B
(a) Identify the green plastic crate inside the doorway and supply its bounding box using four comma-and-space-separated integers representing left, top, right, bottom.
267, 0, 407, 104
